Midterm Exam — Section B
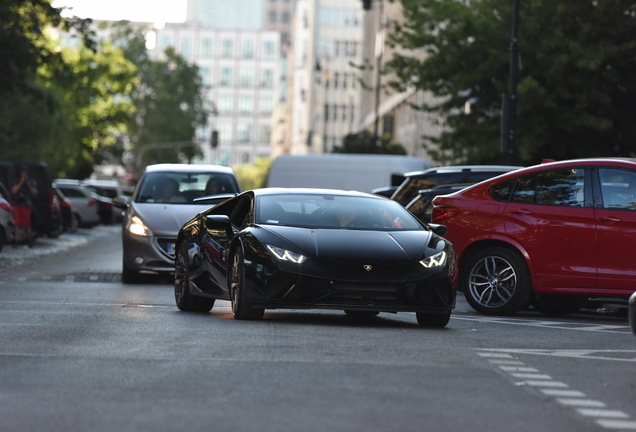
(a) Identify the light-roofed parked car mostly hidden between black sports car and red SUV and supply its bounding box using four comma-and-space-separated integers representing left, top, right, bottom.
391, 165, 522, 206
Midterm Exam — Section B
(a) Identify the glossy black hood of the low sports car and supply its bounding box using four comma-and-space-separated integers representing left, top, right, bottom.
258, 226, 432, 263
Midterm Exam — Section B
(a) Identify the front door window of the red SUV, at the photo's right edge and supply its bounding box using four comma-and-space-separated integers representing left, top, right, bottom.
599, 168, 636, 210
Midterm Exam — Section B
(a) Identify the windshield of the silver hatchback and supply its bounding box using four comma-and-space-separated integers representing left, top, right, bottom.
135, 172, 238, 204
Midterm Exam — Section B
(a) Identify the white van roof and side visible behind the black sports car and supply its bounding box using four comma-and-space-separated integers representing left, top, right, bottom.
267, 154, 433, 193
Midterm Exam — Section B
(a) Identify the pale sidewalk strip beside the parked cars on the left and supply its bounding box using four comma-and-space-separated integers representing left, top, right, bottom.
0, 224, 121, 273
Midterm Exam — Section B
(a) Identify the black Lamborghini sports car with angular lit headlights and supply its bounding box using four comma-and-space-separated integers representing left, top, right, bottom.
175, 188, 455, 327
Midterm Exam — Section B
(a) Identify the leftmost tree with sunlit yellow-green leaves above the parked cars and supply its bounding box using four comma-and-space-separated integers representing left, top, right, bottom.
0, 0, 135, 178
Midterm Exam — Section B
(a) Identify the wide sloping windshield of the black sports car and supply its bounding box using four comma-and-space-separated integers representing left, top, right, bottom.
255, 194, 422, 231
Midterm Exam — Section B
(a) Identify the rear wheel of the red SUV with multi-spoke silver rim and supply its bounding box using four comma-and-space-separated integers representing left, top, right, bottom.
460, 247, 532, 315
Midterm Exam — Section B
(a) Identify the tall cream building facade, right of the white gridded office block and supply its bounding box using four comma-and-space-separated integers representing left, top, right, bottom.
285, 0, 363, 154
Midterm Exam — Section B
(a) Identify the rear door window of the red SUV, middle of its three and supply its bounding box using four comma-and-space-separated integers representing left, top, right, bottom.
536, 168, 585, 207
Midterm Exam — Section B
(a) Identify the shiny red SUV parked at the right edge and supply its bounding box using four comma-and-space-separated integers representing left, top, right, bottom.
432, 158, 636, 315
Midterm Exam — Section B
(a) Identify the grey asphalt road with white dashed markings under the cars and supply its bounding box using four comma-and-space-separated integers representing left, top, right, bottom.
0, 226, 636, 432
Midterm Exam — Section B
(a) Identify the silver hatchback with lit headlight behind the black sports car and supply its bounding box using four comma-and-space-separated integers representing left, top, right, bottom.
113, 164, 240, 283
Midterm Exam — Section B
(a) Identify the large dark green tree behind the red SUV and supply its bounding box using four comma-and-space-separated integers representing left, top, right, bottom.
386, 0, 636, 164
